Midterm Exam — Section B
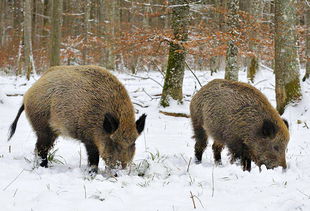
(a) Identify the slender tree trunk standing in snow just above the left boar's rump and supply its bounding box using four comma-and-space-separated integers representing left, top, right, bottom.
24, 0, 34, 80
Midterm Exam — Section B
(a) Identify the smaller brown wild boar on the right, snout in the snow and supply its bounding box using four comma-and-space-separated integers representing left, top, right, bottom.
190, 79, 289, 171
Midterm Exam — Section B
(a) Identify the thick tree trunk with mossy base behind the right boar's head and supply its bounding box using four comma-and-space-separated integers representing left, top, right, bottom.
275, 0, 301, 114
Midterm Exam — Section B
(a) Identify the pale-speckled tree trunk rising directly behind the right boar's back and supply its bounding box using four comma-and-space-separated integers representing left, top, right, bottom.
225, 0, 239, 81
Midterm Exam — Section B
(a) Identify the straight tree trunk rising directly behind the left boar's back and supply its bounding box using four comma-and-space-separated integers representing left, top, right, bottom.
50, 0, 62, 66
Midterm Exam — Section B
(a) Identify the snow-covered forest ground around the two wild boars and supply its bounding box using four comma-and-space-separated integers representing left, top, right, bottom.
0, 69, 310, 211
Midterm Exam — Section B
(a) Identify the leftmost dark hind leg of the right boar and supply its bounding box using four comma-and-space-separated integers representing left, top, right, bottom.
194, 127, 208, 163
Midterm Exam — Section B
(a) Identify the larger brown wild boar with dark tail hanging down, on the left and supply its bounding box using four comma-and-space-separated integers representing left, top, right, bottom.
9, 66, 146, 172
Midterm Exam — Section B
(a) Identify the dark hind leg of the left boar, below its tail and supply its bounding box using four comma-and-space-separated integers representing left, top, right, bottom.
36, 128, 57, 168
